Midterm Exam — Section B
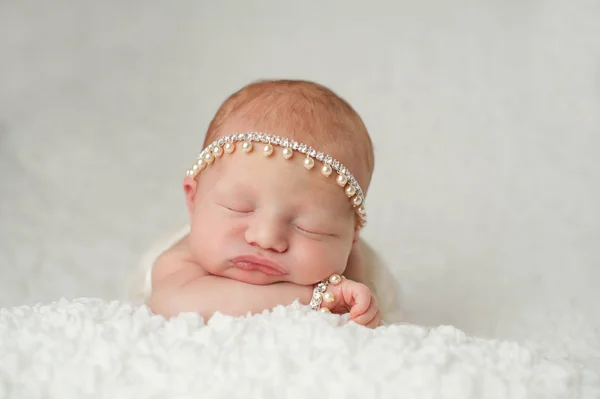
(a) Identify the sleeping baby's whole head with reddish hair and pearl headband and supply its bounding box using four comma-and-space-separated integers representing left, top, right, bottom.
184, 81, 374, 285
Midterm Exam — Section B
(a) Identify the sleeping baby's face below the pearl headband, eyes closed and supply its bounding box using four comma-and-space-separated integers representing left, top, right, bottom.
184, 143, 357, 285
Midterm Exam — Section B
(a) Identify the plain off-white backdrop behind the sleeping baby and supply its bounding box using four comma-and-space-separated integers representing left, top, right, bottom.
0, 0, 600, 352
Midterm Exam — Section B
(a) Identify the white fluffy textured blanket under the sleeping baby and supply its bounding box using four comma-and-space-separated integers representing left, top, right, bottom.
0, 299, 600, 399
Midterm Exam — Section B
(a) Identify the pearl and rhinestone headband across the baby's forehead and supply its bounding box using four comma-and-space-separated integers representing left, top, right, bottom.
186, 132, 367, 227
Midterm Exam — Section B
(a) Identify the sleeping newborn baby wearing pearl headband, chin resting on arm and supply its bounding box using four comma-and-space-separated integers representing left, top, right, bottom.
143, 80, 400, 327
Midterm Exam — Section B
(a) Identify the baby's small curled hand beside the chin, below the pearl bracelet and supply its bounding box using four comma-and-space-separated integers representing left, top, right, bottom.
321, 278, 381, 328
